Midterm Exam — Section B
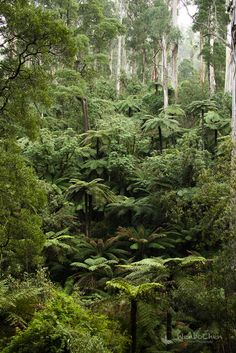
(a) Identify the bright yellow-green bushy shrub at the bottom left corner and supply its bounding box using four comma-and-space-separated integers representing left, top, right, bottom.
2, 292, 127, 353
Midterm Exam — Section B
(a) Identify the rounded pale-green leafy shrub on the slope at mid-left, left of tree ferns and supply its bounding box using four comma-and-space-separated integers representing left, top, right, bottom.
21, 129, 95, 183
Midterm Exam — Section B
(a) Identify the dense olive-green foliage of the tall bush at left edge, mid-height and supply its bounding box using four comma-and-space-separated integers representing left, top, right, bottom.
0, 141, 46, 274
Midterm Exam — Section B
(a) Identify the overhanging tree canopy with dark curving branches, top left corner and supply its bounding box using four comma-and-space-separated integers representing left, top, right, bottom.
0, 1, 76, 136
